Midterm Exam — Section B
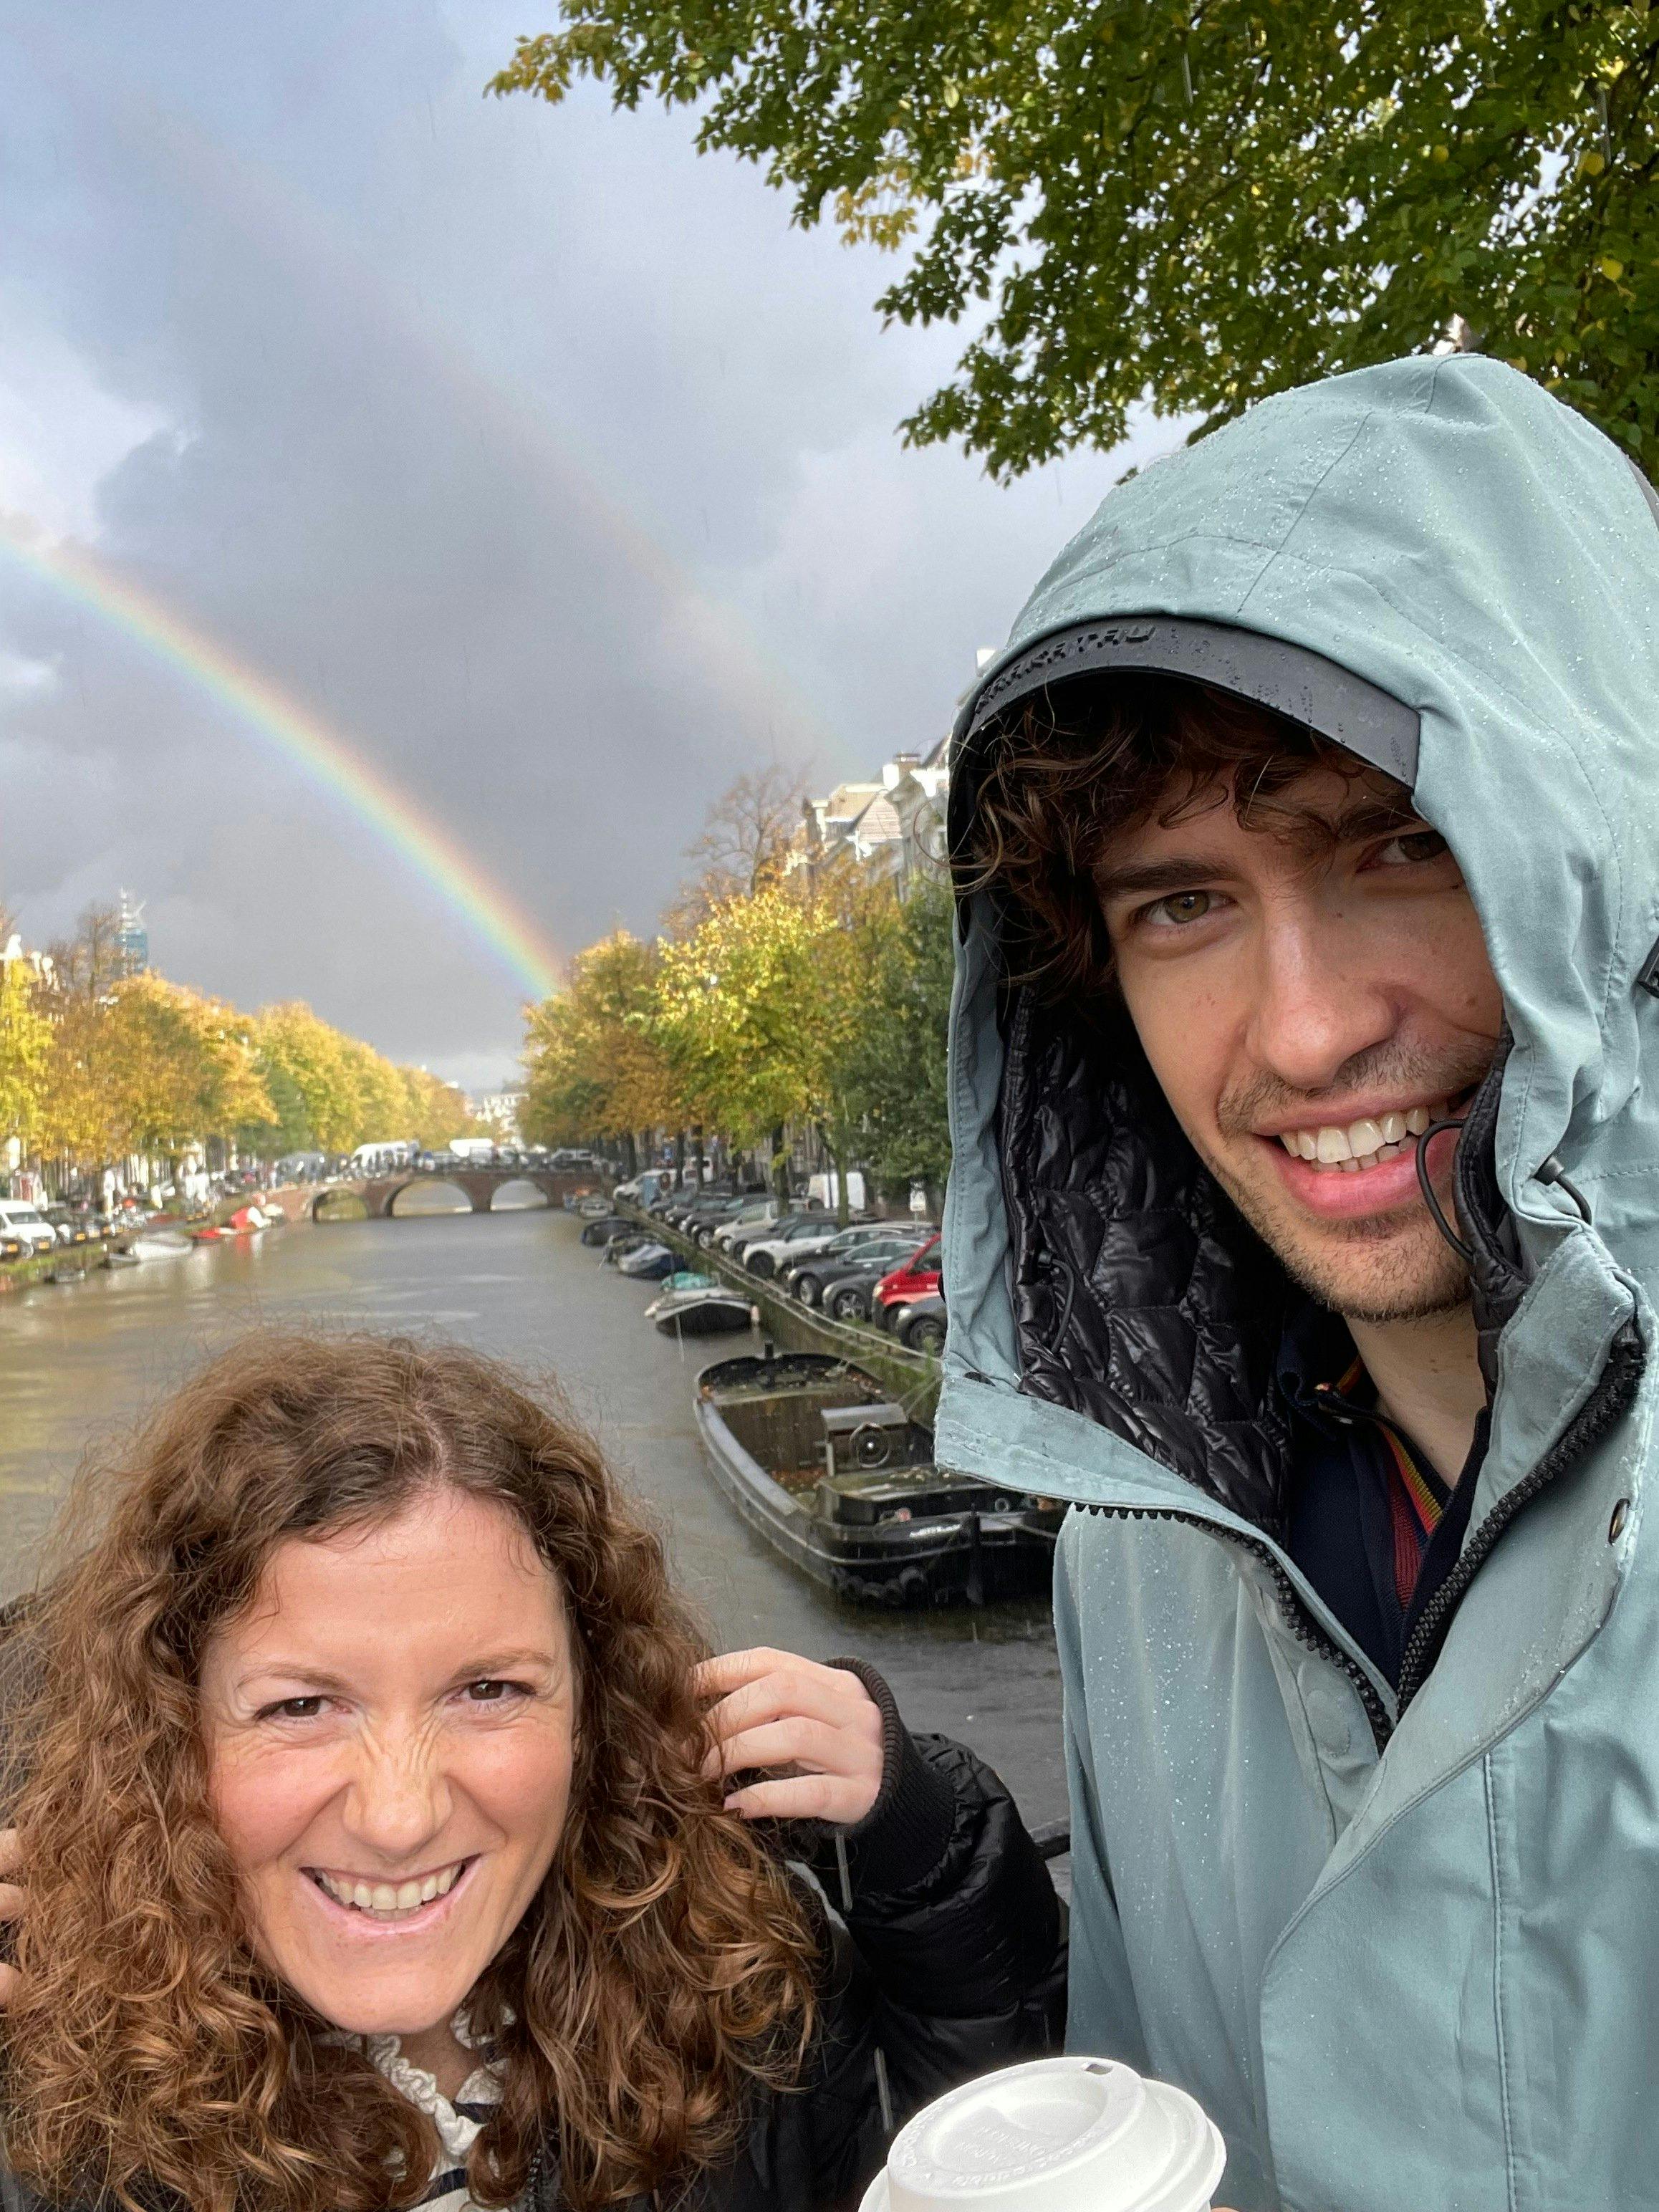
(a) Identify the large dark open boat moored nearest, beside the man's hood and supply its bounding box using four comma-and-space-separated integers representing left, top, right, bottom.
695, 1345, 1064, 1606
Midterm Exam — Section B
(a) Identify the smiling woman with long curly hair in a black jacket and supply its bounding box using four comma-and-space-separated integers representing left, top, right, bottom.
0, 1336, 1064, 2212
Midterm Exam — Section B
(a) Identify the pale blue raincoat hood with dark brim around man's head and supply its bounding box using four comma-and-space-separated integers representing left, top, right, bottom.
938, 356, 1659, 1533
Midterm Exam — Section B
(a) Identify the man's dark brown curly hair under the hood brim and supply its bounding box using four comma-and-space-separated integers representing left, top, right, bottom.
958, 675, 1415, 1006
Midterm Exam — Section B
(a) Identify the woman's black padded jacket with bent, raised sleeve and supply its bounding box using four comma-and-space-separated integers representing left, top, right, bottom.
0, 1659, 1066, 2212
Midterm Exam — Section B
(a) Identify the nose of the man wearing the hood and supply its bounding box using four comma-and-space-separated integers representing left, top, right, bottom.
1248, 900, 1400, 1090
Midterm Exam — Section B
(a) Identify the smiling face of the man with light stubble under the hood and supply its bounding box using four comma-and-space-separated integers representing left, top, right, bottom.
1095, 768, 1502, 1321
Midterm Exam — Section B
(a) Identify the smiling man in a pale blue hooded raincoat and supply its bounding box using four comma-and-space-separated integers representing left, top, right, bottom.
938, 356, 1659, 2212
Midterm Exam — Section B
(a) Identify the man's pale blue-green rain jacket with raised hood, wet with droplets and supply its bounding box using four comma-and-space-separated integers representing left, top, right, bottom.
938, 356, 1659, 2212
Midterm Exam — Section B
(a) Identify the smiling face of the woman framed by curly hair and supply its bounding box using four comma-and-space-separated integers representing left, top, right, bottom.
201, 1489, 575, 2037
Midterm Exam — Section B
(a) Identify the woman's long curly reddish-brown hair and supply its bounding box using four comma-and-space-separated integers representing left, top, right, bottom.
4, 1334, 819, 2212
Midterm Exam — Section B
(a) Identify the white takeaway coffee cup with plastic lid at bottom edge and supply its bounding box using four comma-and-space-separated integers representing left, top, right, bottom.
858, 2057, 1228, 2212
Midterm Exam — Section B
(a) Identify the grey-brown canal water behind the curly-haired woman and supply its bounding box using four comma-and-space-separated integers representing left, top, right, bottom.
0, 1190, 1066, 1820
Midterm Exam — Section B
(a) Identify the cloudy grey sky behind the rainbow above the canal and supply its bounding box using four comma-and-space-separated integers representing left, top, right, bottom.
0, 0, 1170, 1088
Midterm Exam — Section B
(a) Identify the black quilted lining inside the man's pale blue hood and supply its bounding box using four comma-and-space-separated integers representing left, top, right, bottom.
1002, 991, 1524, 1537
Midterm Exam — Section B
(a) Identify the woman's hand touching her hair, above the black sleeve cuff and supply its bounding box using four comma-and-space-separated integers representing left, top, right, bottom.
697, 1645, 883, 1827
